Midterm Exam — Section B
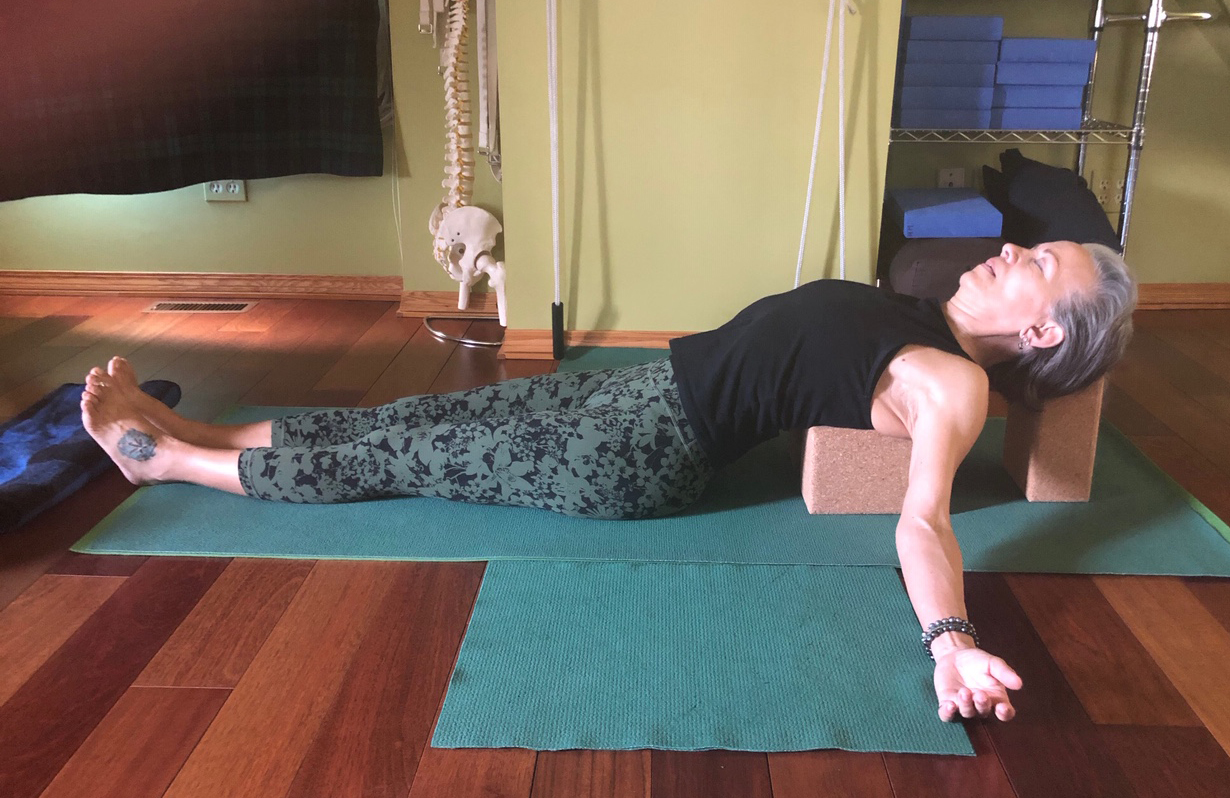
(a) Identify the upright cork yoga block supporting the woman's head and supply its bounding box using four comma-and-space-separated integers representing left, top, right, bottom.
1004, 380, 1106, 502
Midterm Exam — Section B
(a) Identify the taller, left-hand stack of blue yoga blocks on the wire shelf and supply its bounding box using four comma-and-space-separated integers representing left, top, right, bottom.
897, 16, 1004, 130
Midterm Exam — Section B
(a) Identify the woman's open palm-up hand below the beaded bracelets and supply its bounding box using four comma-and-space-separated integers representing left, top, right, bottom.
935, 648, 1023, 721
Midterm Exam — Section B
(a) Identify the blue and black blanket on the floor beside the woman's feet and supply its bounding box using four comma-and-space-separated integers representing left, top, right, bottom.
0, 380, 180, 535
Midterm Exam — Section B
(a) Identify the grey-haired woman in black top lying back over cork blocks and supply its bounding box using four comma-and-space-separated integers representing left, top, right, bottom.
81, 241, 1135, 721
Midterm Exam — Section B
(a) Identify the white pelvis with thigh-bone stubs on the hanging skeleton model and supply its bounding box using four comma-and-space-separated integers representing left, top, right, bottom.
428, 204, 508, 327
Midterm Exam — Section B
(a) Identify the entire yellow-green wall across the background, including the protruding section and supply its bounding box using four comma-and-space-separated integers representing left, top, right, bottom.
0, 0, 1230, 330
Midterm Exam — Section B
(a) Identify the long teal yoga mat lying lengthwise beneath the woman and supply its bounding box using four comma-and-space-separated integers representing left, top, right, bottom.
74, 352, 1230, 575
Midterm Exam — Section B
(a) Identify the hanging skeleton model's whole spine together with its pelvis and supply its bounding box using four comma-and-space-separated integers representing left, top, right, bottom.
428, 0, 508, 327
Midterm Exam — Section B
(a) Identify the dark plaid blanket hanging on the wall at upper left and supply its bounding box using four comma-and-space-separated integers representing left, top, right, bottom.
0, 0, 383, 200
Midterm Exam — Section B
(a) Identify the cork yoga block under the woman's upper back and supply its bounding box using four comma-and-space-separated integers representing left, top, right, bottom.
803, 427, 910, 515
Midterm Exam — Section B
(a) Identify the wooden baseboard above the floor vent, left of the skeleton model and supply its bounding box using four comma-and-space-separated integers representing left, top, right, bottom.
0, 271, 402, 301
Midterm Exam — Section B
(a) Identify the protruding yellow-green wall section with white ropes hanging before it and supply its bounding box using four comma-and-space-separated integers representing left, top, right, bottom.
499, 0, 900, 331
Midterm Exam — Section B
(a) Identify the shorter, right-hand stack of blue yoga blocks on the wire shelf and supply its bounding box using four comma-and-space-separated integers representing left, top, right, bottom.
991, 38, 1096, 130
